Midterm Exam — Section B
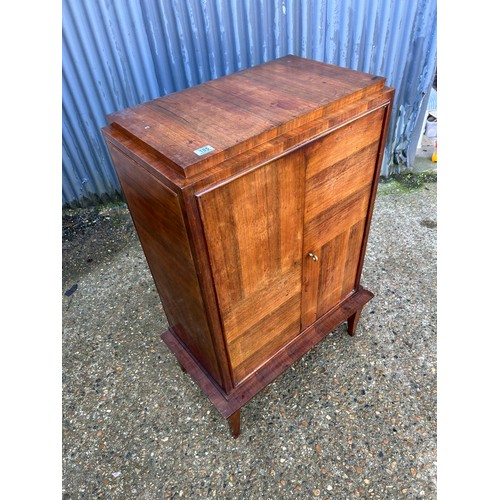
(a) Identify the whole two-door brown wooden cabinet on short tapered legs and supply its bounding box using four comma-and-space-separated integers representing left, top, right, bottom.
103, 56, 394, 435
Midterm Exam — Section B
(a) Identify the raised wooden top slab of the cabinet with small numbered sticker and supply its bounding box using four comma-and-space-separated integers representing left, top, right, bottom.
107, 55, 385, 177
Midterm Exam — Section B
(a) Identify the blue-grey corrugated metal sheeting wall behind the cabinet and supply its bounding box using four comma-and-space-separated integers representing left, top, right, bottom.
62, 0, 437, 206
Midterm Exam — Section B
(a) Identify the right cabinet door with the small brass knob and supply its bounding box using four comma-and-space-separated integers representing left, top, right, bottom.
301, 108, 385, 328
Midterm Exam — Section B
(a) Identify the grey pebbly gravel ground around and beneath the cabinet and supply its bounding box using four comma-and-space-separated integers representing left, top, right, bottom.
62, 178, 437, 499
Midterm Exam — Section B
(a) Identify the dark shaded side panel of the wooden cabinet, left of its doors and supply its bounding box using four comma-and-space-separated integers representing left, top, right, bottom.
108, 145, 221, 385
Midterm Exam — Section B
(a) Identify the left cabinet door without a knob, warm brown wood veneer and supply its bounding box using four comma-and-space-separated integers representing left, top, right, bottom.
197, 151, 305, 383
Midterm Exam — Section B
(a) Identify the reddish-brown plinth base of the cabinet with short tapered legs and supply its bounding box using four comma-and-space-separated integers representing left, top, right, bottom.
161, 286, 373, 428
